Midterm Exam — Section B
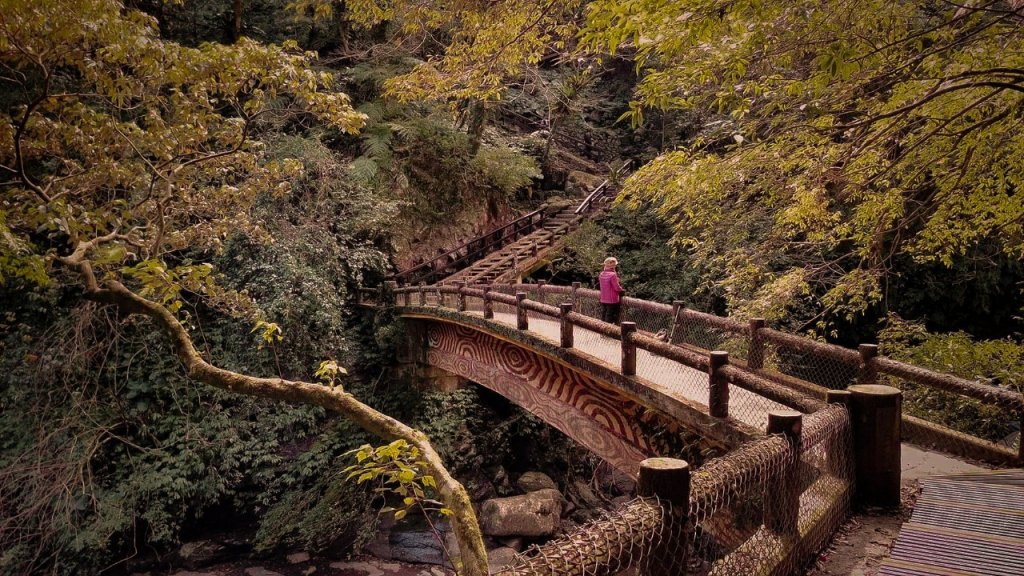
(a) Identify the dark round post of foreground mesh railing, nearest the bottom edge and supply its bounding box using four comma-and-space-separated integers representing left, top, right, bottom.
637, 458, 690, 576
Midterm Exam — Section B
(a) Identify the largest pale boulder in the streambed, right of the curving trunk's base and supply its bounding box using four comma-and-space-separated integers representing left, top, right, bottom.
480, 489, 562, 537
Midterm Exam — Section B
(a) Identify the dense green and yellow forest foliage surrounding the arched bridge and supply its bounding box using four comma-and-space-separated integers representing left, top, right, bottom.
0, 0, 1024, 575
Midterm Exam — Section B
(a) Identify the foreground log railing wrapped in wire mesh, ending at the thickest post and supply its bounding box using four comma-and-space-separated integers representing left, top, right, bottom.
499, 406, 854, 576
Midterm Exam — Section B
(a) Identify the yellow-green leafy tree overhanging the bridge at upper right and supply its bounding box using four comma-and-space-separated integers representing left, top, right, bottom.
584, 0, 1024, 326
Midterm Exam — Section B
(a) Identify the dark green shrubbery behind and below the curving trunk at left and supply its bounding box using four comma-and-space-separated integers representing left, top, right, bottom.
0, 133, 396, 574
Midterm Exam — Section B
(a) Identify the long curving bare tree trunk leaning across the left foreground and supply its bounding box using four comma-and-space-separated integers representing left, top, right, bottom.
59, 247, 487, 576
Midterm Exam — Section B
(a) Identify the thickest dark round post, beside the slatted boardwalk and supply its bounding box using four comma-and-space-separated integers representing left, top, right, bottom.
847, 384, 903, 508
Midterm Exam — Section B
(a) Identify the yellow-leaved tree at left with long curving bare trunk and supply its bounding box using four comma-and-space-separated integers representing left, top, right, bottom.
0, 0, 486, 575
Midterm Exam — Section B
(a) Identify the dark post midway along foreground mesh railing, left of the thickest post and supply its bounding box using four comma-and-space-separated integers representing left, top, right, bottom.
765, 410, 804, 536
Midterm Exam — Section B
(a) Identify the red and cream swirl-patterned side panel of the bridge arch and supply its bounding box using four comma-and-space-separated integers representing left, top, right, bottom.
427, 323, 656, 477
